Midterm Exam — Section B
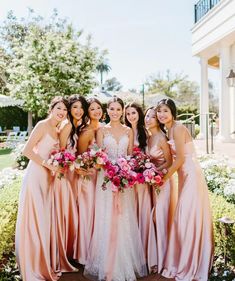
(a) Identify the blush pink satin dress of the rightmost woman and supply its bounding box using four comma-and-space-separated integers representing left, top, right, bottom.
163, 139, 213, 281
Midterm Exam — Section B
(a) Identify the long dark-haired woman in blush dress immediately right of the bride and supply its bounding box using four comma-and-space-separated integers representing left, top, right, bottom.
125, 102, 152, 263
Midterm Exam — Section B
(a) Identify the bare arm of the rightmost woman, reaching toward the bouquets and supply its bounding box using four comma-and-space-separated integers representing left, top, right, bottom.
164, 125, 185, 180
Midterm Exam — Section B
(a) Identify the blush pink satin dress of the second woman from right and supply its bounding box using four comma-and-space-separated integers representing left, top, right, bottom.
148, 138, 176, 273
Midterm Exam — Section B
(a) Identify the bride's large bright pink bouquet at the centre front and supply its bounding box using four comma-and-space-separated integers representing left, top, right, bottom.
102, 157, 137, 192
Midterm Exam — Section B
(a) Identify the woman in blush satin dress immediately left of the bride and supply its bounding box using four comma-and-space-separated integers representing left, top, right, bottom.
76, 98, 103, 265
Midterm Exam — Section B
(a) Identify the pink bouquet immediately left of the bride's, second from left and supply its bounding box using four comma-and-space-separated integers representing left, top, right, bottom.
75, 144, 108, 170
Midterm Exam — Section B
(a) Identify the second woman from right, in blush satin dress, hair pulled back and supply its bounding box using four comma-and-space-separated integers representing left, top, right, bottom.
145, 107, 173, 273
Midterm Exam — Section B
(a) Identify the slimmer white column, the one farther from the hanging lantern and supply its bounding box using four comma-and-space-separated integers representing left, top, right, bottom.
198, 57, 209, 139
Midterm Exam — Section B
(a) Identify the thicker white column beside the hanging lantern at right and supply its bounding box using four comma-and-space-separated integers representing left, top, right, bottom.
218, 46, 231, 142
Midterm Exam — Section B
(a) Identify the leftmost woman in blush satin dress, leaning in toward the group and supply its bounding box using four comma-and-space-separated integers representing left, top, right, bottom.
15, 97, 67, 281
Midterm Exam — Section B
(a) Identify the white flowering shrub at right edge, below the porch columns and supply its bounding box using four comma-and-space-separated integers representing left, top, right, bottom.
199, 156, 235, 203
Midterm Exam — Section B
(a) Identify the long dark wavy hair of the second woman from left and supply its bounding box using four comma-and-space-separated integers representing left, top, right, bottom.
68, 94, 88, 146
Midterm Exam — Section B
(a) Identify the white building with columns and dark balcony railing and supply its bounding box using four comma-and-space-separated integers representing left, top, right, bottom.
192, 0, 235, 142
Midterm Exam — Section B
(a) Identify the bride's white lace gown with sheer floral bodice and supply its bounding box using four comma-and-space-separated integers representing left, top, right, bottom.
85, 128, 147, 281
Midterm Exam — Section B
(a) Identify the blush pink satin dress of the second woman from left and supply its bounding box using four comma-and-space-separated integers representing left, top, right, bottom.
52, 135, 78, 272
